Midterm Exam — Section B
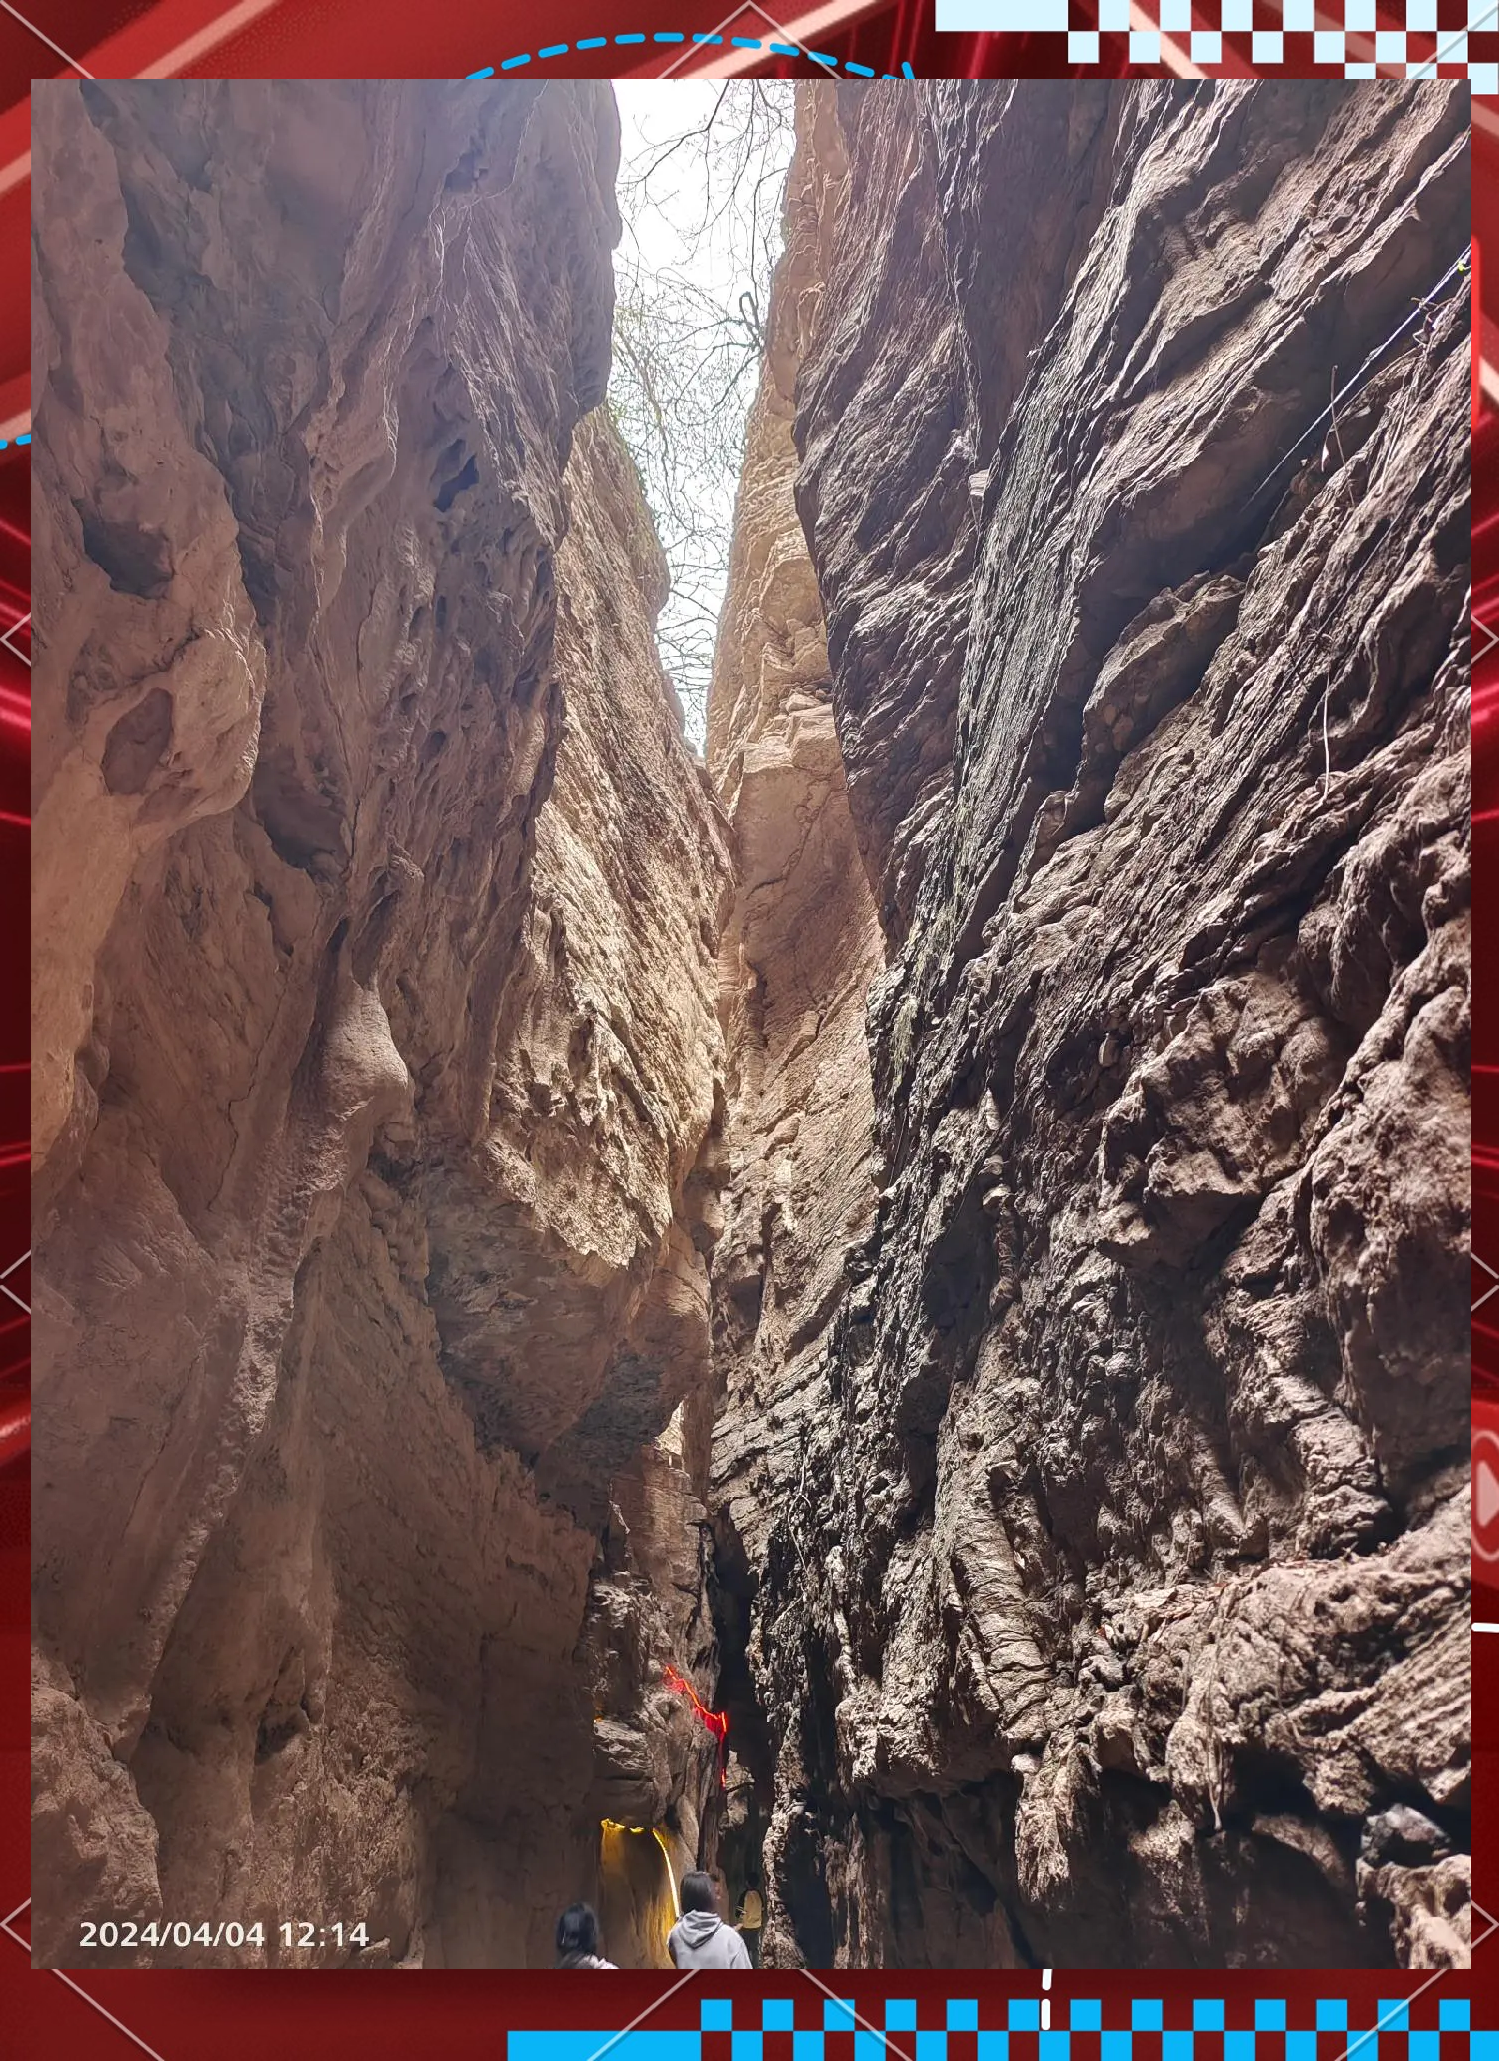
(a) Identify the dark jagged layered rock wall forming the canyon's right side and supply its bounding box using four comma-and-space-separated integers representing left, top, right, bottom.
709, 82, 1468, 1966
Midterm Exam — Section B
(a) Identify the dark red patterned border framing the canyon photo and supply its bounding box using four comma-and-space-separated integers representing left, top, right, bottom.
0, 12, 1499, 2061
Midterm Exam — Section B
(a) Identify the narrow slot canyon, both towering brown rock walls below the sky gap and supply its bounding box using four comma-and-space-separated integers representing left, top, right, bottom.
33, 78, 1472, 1968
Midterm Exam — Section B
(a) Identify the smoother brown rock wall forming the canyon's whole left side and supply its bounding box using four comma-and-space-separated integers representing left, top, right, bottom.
33, 82, 726, 1966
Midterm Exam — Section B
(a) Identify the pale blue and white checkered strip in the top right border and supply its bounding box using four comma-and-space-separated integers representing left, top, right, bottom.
936, 0, 1499, 93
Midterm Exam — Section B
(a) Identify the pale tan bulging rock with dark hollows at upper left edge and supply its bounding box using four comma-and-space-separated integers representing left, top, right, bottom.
31, 87, 266, 1171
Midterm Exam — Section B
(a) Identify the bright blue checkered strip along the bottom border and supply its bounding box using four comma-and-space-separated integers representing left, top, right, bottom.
509, 1989, 1499, 2061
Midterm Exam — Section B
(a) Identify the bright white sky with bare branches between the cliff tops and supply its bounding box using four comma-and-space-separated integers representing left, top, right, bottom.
608, 78, 792, 752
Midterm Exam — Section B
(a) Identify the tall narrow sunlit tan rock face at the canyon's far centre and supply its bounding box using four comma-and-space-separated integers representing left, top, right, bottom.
707, 97, 885, 1964
